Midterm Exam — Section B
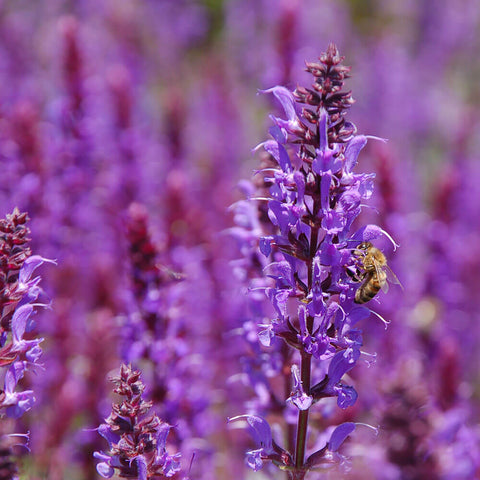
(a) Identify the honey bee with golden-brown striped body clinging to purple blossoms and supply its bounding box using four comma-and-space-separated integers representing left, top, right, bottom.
354, 242, 401, 303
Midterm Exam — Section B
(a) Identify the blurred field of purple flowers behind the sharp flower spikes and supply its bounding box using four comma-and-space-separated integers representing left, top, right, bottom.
0, 0, 480, 480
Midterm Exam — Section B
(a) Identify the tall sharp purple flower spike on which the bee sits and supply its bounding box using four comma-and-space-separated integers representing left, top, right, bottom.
232, 44, 395, 479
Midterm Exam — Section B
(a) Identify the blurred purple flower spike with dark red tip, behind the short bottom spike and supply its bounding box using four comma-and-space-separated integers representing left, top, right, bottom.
116, 203, 219, 475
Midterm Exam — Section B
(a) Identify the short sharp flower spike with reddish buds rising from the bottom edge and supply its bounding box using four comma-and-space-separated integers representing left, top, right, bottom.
94, 364, 180, 480
